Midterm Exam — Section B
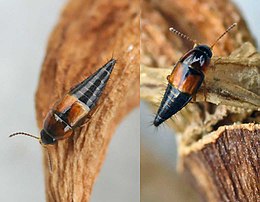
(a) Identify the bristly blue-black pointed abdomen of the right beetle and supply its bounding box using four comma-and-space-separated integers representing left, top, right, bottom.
153, 83, 192, 127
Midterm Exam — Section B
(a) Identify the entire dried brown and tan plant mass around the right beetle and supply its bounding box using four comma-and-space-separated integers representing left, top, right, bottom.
140, 0, 260, 202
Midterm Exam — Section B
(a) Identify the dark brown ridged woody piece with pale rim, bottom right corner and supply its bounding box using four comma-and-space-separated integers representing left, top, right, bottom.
180, 124, 260, 202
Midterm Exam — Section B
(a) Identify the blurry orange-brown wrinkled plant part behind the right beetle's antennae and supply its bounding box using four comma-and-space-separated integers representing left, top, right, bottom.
141, 0, 254, 68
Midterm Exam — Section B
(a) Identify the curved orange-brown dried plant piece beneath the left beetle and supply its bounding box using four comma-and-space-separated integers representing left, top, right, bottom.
36, 0, 140, 202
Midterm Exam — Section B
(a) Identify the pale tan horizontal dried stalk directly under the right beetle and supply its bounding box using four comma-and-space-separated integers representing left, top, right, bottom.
141, 43, 260, 111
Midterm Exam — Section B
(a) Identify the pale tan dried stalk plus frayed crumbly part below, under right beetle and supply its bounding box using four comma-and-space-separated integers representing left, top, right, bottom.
140, 43, 260, 144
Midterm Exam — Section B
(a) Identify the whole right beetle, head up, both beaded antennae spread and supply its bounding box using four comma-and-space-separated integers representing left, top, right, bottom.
153, 23, 237, 127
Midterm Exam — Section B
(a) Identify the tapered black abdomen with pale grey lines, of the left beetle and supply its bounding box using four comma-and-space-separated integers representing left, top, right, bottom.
70, 59, 116, 110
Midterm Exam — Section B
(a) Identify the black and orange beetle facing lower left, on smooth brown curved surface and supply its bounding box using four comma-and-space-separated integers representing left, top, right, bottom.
9, 59, 116, 146
